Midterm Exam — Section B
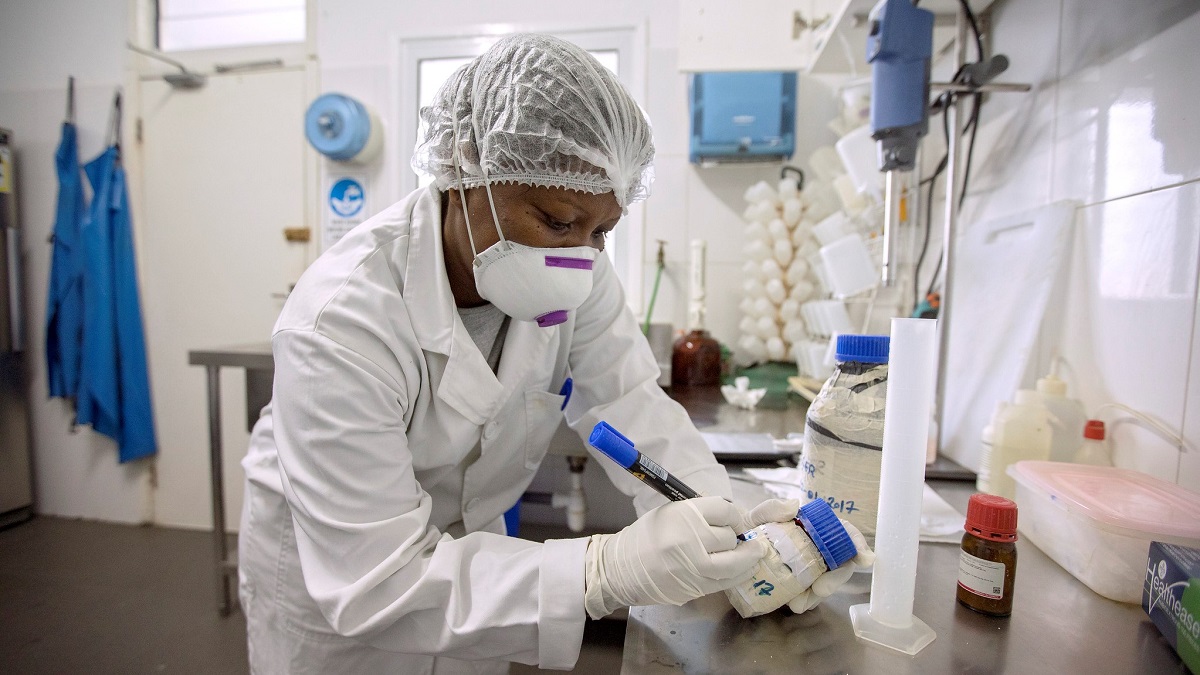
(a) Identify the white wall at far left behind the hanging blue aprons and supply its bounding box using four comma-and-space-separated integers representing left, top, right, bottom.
0, 0, 150, 522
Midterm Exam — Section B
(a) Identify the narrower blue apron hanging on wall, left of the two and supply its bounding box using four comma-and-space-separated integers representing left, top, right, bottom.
46, 78, 88, 399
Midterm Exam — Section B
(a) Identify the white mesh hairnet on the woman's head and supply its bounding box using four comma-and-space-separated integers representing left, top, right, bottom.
413, 35, 654, 208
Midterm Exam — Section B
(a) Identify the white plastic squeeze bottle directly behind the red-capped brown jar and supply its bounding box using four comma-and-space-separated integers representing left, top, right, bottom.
989, 389, 1052, 500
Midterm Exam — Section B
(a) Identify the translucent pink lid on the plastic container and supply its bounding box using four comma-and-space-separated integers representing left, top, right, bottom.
1008, 460, 1200, 546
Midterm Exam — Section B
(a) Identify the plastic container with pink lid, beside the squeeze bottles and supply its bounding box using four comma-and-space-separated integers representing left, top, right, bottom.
1008, 461, 1200, 603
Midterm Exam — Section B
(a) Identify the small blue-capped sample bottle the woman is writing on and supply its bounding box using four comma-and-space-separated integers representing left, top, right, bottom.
725, 500, 858, 619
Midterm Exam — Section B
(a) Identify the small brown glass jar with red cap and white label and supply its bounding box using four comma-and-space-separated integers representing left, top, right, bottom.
958, 494, 1016, 616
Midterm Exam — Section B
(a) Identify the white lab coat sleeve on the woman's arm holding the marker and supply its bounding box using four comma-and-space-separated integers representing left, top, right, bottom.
272, 329, 587, 669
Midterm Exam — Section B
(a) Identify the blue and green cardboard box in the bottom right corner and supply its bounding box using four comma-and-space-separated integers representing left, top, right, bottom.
1141, 542, 1200, 675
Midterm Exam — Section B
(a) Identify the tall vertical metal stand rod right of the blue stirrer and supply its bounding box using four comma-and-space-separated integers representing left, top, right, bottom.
934, 10, 967, 453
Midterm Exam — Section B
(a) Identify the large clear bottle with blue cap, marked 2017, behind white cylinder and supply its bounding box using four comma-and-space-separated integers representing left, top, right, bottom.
800, 335, 890, 543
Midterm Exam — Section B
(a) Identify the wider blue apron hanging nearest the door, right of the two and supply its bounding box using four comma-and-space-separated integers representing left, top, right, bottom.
76, 94, 157, 462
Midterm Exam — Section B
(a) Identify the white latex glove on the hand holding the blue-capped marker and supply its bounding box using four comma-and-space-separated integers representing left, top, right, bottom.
583, 497, 772, 619
